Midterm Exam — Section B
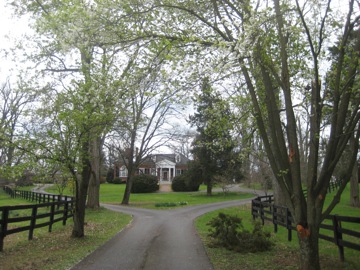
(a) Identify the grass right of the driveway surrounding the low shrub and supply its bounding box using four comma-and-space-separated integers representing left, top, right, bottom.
195, 185, 360, 270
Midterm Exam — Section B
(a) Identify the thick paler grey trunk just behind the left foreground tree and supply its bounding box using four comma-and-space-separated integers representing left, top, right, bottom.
86, 137, 102, 209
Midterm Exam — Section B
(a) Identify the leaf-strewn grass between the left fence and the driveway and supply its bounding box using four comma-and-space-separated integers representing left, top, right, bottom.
0, 204, 131, 270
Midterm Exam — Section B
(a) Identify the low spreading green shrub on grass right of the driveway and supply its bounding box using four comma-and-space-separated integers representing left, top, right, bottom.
208, 213, 273, 253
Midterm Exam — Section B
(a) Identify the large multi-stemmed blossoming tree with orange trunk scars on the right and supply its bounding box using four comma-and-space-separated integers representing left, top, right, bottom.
121, 0, 360, 269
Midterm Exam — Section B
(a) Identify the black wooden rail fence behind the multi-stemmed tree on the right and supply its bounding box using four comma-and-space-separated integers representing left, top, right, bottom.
251, 195, 360, 261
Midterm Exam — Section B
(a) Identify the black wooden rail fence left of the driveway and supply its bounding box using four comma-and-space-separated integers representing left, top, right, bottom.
0, 187, 74, 251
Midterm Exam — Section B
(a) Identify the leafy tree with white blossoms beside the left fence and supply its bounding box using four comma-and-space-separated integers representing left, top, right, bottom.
12, 0, 133, 237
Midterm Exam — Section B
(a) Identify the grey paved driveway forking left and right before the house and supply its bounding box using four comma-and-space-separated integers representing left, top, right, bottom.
72, 199, 251, 270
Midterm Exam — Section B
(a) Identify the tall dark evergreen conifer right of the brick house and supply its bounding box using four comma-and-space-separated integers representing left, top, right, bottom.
190, 78, 241, 193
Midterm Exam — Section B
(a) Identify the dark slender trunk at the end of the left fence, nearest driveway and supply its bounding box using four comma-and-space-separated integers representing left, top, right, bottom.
71, 141, 91, 238
